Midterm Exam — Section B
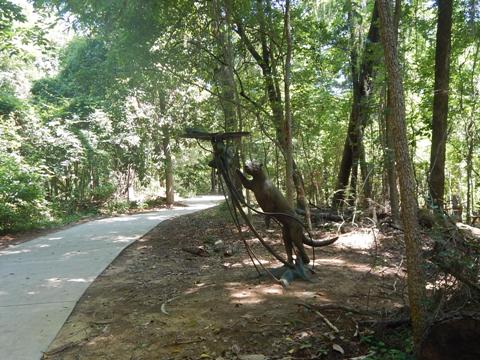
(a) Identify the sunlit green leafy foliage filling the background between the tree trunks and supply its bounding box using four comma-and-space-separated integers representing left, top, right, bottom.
0, 0, 472, 236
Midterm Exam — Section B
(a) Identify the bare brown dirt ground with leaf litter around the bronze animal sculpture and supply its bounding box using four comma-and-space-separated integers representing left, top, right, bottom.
40, 207, 405, 360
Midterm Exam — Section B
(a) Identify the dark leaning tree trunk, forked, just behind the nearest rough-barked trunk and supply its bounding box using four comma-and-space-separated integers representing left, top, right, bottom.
333, 2, 379, 208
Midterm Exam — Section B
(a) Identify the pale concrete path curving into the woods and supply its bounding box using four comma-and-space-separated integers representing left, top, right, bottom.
0, 196, 220, 360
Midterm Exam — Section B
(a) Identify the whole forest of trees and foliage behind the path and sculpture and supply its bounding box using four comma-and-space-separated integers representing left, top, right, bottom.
0, 0, 480, 359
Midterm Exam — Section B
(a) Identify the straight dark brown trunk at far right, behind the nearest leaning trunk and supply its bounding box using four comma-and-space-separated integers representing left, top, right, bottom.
428, 0, 453, 210
